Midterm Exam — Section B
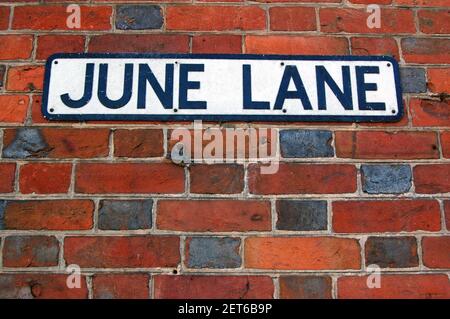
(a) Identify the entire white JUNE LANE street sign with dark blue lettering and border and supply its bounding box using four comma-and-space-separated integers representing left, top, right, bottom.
42, 54, 403, 122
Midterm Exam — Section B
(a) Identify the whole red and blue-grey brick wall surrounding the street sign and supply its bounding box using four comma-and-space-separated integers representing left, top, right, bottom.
0, 0, 450, 298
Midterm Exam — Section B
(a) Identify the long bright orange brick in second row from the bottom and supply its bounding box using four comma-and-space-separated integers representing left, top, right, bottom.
244, 237, 361, 270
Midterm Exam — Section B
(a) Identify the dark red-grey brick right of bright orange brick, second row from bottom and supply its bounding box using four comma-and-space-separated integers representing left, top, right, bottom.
365, 237, 419, 268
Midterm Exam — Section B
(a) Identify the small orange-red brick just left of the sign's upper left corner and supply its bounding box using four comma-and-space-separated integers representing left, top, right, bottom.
6, 65, 44, 92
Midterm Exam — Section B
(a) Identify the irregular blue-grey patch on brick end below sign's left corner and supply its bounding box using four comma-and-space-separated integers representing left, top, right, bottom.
3, 128, 49, 158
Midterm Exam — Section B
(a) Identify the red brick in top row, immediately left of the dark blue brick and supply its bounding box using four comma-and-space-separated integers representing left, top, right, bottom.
12, 5, 112, 31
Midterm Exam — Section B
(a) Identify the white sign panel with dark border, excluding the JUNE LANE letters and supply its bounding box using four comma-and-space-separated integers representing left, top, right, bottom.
43, 54, 402, 121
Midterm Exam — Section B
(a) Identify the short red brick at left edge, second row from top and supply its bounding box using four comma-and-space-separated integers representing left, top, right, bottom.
0, 35, 33, 60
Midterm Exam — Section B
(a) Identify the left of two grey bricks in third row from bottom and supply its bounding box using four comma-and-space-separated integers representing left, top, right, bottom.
98, 199, 153, 230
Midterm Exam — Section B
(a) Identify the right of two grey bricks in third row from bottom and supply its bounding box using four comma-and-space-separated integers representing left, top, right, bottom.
277, 200, 328, 231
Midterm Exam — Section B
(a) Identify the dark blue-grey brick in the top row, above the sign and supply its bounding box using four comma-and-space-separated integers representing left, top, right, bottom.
116, 5, 164, 30
